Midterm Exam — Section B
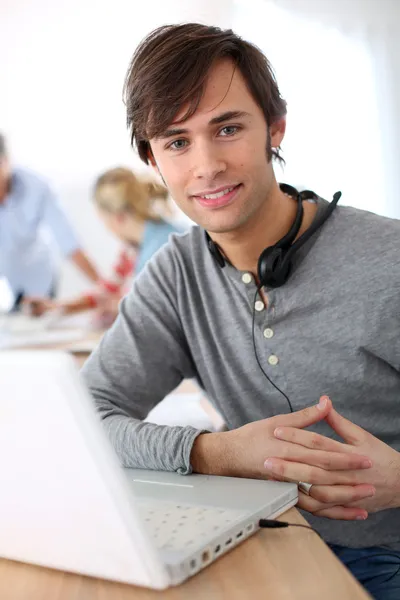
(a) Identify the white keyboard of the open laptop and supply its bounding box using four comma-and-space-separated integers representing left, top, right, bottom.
138, 501, 247, 551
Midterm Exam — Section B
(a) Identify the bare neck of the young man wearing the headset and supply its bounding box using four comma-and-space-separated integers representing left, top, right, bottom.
211, 185, 317, 275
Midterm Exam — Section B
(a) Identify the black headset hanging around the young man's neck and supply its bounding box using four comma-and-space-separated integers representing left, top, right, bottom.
205, 183, 342, 288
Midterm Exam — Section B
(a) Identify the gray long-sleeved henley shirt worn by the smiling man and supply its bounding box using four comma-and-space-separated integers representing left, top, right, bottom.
83, 200, 400, 547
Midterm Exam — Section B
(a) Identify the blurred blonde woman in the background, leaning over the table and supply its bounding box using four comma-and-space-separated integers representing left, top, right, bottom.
27, 167, 181, 326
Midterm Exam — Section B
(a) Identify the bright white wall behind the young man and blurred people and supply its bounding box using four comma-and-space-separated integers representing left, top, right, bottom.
0, 0, 400, 295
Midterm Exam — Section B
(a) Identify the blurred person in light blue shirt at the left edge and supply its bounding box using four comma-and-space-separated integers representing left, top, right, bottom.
0, 134, 99, 306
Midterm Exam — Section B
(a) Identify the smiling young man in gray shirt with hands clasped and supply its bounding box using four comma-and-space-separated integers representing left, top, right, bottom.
83, 24, 400, 600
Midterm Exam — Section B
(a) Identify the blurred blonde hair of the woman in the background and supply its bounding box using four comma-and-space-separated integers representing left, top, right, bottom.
93, 167, 168, 221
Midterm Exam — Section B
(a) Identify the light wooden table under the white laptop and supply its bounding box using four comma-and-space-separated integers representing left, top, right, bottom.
0, 332, 370, 600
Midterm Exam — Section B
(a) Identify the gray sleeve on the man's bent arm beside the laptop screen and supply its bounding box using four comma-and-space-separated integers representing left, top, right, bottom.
82, 241, 205, 474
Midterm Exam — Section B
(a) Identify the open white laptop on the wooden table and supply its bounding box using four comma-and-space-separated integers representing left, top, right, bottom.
0, 350, 297, 589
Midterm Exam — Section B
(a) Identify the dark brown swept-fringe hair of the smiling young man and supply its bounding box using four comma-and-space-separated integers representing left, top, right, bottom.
124, 23, 286, 164
